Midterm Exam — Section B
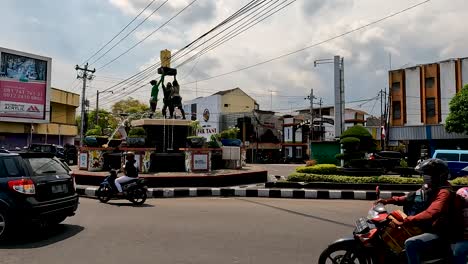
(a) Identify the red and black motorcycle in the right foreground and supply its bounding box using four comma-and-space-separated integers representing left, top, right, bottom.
318, 187, 452, 264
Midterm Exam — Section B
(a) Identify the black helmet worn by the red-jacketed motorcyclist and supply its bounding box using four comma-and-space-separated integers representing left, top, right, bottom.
414, 159, 449, 186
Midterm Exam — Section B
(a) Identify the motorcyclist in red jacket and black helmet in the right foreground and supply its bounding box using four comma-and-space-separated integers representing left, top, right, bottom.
378, 158, 453, 264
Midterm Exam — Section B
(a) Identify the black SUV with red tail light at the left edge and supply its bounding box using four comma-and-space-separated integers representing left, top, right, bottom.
0, 152, 78, 240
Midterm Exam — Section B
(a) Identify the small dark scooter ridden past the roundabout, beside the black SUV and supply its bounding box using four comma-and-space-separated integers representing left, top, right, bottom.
96, 170, 147, 205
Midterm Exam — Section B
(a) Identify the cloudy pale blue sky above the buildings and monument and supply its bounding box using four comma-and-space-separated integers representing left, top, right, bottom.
0, 0, 468, 115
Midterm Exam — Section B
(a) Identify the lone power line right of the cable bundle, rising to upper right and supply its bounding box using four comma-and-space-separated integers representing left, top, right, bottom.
181, 0, 431, 84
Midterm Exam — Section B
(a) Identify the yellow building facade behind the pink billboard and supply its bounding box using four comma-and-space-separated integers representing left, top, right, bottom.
0, 88, 80, 149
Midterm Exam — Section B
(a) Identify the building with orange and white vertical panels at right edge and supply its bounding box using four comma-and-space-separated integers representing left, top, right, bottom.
388, 58, 468, 163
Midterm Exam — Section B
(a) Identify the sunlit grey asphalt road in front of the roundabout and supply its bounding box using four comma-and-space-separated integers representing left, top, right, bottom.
0, 198, 370, 264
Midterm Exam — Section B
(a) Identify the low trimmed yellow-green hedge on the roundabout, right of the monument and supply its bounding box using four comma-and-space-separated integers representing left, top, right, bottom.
287, 164, 468, 186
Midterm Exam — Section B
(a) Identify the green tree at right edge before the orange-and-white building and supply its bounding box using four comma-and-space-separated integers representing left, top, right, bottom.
445, 84, 468, 134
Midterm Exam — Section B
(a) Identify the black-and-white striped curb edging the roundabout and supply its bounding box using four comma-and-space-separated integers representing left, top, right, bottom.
77, 186, 407, 200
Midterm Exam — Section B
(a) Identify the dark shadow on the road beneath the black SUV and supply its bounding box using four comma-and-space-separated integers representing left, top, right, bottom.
0, 224, 84, 249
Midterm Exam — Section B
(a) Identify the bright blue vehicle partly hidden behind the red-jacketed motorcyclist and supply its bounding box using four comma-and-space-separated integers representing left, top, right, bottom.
432, 149, 468, 179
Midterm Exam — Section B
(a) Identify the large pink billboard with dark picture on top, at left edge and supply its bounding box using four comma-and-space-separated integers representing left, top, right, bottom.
0, 47, 52, 123
